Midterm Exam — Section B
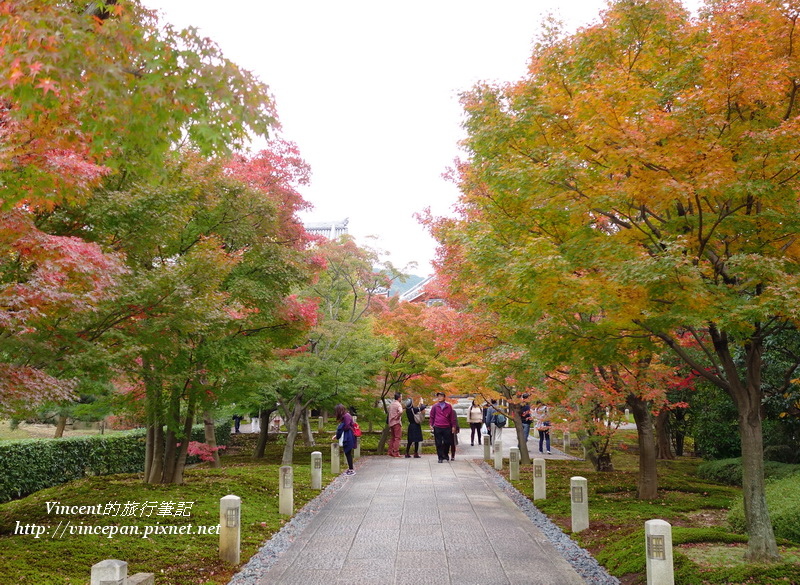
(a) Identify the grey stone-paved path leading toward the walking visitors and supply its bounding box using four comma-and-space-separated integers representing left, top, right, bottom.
253, 442, 584, 585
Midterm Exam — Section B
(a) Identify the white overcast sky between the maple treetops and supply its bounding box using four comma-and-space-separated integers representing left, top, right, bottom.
142, 0, 680, 276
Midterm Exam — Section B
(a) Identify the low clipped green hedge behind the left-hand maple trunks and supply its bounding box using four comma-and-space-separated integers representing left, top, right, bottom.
0, 421, 231, 502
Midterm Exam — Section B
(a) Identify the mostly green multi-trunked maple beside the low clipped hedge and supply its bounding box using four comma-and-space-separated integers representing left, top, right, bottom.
33, 146, 316, 483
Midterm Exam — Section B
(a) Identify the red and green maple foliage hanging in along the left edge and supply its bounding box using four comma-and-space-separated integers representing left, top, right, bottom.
0, 0, 276, 420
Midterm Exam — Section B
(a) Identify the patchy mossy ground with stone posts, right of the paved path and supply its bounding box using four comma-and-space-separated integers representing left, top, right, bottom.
502, 431, 800, 585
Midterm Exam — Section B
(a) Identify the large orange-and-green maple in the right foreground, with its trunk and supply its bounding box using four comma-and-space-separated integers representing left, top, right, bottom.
432, 0, 800, 561
